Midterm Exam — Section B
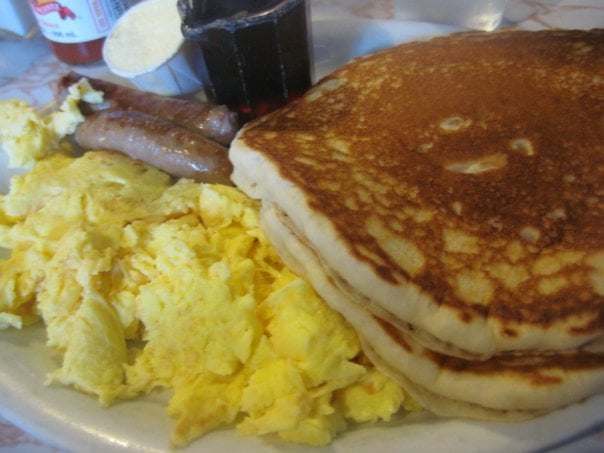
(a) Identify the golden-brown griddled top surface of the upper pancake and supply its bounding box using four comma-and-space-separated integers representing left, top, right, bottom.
242, 30, 604, 336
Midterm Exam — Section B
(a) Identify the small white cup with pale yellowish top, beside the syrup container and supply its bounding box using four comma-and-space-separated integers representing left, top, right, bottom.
103, 0, 203, 96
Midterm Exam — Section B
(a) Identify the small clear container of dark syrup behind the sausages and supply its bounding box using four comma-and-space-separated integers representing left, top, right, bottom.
179, 0, 312, 123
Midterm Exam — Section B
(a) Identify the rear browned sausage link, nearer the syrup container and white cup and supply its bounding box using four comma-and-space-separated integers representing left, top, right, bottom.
55, 72, 237, 145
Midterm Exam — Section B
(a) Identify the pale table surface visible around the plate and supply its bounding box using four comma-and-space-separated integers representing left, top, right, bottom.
0, 0, 604, 453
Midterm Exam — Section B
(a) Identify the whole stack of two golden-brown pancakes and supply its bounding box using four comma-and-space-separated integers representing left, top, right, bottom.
230, 30, 604, 420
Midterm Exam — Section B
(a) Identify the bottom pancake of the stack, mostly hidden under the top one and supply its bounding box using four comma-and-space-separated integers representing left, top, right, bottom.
262, 204, 604, 421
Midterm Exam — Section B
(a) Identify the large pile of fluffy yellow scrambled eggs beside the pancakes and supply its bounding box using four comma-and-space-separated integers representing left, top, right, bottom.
0, 95, 417, 446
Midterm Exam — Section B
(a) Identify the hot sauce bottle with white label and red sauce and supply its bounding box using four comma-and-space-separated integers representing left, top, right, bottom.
29, 0, 130, 64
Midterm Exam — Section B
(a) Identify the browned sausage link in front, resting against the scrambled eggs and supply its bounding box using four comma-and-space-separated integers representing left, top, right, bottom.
75, 110, 233, 185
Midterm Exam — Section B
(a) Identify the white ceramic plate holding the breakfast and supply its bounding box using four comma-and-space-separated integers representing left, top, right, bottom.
0, 20, 604, 453
